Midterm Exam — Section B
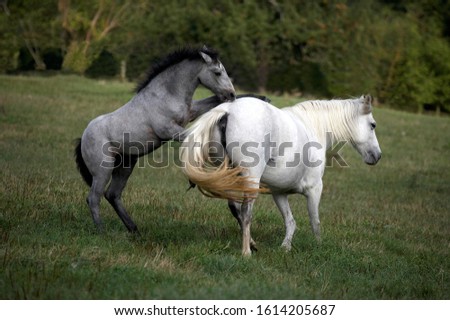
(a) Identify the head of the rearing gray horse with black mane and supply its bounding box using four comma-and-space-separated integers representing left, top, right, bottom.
199, 48, 236, 101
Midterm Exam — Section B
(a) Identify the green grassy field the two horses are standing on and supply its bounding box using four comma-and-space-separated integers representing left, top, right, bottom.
0, 76, 450, 299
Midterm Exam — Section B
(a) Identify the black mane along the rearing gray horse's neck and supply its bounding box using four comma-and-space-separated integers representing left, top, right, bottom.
136, 47, 219, 93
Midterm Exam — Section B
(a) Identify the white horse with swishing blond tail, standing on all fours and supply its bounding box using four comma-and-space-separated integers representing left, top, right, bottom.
180, 95, 381, 255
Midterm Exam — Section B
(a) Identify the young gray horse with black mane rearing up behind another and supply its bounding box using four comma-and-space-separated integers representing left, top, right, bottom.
75, 47, 235, 232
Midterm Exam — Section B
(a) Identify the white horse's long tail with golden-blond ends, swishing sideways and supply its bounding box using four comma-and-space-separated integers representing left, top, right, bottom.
180, 109, 262, 201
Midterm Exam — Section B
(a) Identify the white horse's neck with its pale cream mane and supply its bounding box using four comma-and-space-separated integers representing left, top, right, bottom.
283, 99, 359, 149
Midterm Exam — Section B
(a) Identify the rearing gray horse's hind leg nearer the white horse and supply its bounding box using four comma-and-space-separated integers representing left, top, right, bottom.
105, 155, 138, 232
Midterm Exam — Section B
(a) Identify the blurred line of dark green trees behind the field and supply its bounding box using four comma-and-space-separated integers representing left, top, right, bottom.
0, 0, 450, 112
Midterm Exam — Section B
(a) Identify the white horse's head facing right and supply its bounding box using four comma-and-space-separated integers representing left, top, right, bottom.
352, 95, 381, 165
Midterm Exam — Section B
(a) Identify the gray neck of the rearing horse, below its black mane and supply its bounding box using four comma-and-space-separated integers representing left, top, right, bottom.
137, 60, 202, 105
